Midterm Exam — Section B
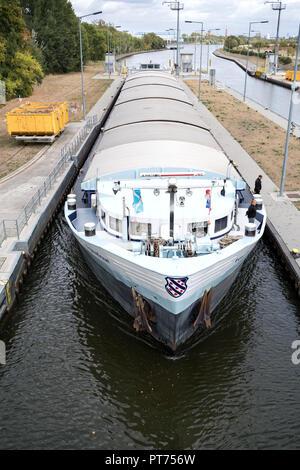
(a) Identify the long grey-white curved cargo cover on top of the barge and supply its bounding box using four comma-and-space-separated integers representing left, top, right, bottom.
84, 71, 240, 181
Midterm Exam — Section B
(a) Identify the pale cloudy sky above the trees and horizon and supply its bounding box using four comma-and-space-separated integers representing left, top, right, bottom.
70, 0, 300, 38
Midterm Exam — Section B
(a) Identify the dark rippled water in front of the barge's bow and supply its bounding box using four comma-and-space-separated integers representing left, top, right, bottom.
0, 214, 300, 450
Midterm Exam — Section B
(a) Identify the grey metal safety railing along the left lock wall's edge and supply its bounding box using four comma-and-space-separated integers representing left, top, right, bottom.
0, 115, 98, 246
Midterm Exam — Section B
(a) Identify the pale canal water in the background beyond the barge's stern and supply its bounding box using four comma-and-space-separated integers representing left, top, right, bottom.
126, 45, 300, 125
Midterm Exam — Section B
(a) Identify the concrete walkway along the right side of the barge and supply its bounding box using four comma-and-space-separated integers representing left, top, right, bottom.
181, 81, 300, 280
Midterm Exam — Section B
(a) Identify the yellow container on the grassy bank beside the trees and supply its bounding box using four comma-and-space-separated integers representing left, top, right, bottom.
6, 102, 69, 142
